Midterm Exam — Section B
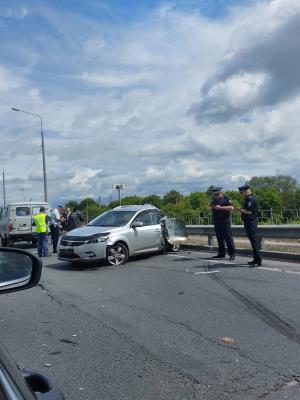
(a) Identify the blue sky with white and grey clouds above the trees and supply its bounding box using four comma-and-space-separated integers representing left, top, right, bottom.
0, 0, 300, 205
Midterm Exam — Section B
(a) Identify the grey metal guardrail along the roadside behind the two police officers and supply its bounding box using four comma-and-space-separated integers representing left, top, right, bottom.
186, 225, 300, 250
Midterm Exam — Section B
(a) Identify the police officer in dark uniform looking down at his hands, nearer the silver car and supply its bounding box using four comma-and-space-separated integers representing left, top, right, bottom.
210, 187, 235, 260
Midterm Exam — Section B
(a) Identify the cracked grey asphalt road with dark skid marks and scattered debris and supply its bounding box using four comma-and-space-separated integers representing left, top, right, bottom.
0, 251, 300, 400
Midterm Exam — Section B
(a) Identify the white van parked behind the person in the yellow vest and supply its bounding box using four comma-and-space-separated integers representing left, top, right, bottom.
0, 201, 50, 247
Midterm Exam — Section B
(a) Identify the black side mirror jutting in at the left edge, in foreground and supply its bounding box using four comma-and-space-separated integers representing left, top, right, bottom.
0, 248, 42, 294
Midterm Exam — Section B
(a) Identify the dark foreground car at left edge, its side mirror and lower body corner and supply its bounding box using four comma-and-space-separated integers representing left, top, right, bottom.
0, 248, 64, 400
